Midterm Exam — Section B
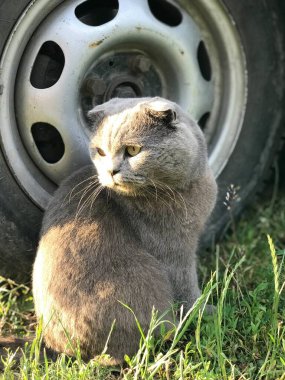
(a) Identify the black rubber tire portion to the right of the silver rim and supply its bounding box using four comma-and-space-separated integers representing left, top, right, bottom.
204, 0, 285, 244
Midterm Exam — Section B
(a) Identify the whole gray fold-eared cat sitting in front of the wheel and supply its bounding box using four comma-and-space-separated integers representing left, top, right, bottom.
33, 97, 216, 363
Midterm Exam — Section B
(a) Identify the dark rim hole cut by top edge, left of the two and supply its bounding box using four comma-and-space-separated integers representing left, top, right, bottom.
75, 0, 119, 26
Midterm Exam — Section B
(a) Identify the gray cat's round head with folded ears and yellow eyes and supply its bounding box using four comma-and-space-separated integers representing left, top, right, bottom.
89, 97, 207, 195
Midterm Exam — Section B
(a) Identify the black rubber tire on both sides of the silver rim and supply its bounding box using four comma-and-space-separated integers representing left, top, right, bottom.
0, 0, 285, 280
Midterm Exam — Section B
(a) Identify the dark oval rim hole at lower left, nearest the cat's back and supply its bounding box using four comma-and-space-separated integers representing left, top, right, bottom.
31, 122, 65, 164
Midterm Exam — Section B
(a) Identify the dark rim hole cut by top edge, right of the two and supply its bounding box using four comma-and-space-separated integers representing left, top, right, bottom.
148, 0, 183, 26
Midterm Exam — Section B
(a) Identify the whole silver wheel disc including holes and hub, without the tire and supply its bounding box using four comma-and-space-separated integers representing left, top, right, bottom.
0, 0, 247, 209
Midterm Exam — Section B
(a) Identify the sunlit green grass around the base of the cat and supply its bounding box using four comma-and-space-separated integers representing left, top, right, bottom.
0, 189, 285, 380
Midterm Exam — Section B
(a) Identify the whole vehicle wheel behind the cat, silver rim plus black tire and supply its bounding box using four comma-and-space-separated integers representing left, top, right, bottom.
0, 0, 285, 278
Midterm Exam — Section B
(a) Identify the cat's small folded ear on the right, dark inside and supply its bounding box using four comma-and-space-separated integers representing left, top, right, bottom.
146, 98, 177, 129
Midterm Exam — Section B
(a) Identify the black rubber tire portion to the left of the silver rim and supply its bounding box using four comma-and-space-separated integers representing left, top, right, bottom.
0, 0, 42, 281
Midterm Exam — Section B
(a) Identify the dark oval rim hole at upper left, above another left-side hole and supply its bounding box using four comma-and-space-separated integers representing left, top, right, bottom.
30, 41, 65, 89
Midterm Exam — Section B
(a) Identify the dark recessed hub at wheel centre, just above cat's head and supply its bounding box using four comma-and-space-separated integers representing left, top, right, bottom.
80, 51, 163, 115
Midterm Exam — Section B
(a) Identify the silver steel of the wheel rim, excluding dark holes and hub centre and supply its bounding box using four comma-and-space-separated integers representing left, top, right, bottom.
0, 0, 247, 209
